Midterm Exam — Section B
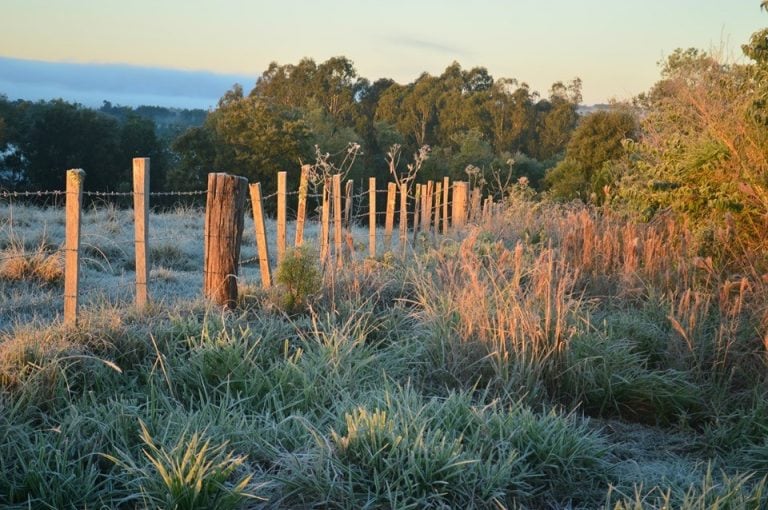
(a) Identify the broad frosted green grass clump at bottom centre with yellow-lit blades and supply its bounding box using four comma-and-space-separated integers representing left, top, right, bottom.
280, 389, 607, 508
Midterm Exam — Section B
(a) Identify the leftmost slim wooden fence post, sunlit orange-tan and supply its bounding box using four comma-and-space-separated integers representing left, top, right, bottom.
64, 169, 85, 326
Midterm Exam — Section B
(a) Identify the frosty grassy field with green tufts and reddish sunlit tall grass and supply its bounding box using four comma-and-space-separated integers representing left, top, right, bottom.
0, 195, 768, 509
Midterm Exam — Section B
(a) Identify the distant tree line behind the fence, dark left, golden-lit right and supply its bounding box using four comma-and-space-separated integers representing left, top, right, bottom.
0, 57, 581, 194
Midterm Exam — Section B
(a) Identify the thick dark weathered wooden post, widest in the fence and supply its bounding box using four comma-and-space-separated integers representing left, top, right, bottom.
203, 173, 248, 309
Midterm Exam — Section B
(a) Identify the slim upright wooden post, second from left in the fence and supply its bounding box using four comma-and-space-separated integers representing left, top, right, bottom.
133, 158, 149, 309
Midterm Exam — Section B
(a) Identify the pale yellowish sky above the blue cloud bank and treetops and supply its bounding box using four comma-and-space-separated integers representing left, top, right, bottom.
0, 0, 768, 104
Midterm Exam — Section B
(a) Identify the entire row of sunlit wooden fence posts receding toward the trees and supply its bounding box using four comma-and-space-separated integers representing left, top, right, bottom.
58, 158, 494, 324
